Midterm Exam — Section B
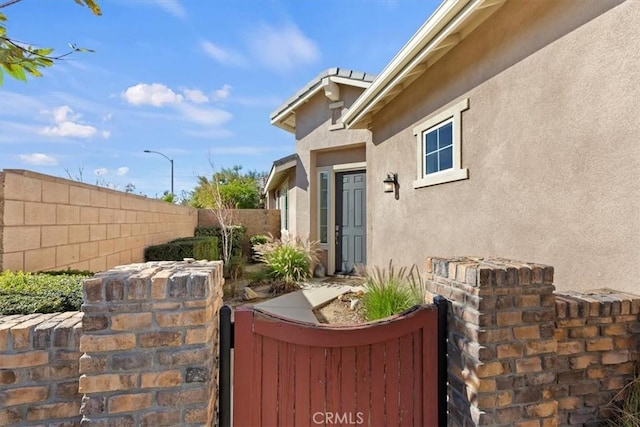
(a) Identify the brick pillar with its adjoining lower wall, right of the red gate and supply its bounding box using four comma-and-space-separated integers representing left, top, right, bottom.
425, 258, 640, 427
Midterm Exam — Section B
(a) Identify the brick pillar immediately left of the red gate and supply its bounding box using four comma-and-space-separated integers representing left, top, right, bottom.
80, 261, 224, 426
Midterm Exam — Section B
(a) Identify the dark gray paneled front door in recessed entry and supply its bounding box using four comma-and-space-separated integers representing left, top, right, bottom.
336, 171, 367, 274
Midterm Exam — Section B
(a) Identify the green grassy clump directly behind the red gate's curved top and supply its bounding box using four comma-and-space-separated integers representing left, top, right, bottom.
360, 262, 425, 321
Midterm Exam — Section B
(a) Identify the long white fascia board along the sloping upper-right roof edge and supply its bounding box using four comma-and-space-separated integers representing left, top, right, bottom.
342, 0, 472, 128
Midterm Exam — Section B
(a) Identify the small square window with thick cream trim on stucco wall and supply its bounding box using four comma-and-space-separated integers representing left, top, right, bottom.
413, 99, 469, 188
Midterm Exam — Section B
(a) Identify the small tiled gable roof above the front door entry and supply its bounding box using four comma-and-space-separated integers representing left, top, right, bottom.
269, 67, 375, 132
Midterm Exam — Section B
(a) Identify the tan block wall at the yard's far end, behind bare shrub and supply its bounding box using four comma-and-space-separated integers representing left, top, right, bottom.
198, 209, 280, 255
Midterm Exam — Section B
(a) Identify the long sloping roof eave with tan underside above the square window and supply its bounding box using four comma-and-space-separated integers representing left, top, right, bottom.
342, 0, 506, 128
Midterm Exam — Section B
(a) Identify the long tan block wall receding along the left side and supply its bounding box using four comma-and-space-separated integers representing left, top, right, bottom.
0, 170, 198, 272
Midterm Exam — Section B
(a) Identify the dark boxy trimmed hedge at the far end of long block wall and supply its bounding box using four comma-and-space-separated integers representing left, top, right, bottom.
144, 236, 219, 261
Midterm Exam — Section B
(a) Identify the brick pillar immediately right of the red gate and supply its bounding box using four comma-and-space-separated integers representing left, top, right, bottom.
425, 258, 558, 427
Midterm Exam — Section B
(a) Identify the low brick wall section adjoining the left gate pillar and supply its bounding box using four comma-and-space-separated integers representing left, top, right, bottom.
0, 312, 82, 426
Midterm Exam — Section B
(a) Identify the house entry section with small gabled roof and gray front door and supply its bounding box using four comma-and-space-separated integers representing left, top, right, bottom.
265, 68, 374, 274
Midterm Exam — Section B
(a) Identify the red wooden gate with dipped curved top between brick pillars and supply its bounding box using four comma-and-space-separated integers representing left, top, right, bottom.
233, 306, 438, 427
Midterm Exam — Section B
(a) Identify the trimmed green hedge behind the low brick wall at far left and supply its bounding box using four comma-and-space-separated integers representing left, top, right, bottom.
0, 270, 92, 314
